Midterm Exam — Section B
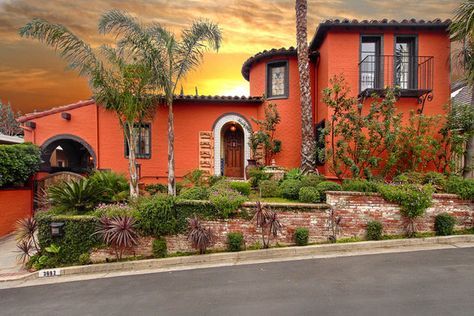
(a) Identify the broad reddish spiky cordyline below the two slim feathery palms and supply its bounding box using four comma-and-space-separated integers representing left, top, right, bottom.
96, 216, 138, 261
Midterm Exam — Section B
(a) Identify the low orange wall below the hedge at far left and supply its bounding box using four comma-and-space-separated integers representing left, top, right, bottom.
0, 188, 33, 237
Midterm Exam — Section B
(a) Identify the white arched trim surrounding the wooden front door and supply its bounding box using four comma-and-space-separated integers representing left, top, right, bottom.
213, 114, 250, 177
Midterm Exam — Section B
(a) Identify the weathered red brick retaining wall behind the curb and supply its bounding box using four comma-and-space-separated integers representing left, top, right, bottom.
167, 192, 474, 253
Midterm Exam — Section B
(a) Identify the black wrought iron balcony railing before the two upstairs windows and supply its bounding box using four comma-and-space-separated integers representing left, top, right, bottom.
359, 54, 434, 98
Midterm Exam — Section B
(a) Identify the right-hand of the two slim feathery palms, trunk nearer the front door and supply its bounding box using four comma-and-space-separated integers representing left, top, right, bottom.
99, 10, 222, 195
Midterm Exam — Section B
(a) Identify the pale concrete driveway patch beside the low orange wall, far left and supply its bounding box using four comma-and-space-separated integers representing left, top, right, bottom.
0, 235, 29, 279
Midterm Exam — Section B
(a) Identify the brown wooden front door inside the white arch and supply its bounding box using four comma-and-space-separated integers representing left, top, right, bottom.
224, 128, 244, 178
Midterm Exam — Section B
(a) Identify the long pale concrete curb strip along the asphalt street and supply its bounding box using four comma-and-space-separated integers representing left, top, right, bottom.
0, 235, 474, 288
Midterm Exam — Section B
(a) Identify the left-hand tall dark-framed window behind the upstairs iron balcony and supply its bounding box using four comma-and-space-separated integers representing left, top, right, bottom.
359, 35, 383, 91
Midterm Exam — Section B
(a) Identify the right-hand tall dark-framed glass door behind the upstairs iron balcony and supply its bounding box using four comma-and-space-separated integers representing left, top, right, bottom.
394, 36, 418, 90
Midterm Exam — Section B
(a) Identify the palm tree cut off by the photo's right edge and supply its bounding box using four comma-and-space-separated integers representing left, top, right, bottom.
449, 0, 474, 177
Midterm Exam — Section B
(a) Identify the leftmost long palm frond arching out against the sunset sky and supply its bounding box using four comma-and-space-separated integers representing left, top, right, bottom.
20, 19, 101, 75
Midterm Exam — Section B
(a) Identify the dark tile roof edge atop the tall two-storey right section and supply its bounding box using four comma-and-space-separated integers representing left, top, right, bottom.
309, 19, 451, 50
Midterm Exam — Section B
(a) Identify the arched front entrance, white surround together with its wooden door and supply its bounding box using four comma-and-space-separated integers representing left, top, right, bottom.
212, 113, 251, 178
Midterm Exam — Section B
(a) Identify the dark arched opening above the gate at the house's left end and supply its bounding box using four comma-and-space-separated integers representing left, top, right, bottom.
41, 134, 96, 174
